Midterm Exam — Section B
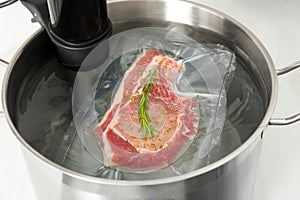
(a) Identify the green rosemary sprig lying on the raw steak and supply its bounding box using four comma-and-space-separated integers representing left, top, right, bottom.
138, 68, 156, 138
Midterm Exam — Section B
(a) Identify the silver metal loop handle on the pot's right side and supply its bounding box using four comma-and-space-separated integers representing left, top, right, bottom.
269, 60, 300, 126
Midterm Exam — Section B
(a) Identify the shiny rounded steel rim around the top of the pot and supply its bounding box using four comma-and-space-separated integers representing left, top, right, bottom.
2, 0, 278, 186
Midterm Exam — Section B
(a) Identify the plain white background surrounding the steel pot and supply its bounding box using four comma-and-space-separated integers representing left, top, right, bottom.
0, 0, 300, 200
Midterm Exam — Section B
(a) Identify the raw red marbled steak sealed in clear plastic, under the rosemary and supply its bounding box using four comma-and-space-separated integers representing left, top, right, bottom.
95, 50, 200, 171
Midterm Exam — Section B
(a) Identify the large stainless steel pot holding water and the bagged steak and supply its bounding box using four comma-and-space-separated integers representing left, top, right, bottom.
2, 0, 300, 200
